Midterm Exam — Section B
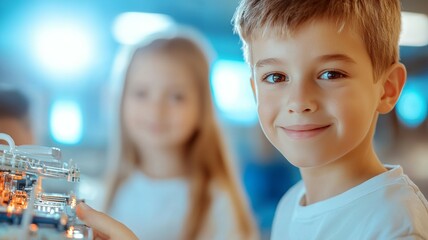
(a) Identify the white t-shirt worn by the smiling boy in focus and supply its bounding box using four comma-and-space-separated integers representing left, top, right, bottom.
271, 166, 428, 240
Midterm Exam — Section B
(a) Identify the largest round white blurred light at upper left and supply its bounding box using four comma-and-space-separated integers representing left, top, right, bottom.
34, 19, 94, 77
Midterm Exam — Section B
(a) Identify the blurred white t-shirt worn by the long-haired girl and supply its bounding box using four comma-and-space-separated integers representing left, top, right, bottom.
110, 171, 243, 240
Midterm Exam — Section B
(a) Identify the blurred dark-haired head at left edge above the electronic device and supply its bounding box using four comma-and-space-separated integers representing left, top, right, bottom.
0, 85, 34, 145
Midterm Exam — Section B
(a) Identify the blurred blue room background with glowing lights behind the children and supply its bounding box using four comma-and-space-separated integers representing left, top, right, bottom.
0, 0, 428, 238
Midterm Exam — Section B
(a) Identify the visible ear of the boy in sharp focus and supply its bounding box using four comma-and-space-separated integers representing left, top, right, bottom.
377, 63, 407, 114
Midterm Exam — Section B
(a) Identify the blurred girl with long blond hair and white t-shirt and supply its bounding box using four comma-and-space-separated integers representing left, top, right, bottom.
80, 26, 258, 240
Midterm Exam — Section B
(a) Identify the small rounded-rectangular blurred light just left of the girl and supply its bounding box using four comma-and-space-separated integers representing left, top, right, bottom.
50, 100, 83, 144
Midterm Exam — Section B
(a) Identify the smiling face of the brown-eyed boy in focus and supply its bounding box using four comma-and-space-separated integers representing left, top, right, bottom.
250, 20, 383, 167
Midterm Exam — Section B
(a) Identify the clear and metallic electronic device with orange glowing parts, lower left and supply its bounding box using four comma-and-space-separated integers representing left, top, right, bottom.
0, 133, 92, 240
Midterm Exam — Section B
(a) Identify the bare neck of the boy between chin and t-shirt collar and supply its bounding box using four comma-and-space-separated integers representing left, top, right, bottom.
300, 145, 386, 205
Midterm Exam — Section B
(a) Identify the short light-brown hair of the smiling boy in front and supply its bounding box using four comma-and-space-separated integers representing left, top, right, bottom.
234, 0, 401, 78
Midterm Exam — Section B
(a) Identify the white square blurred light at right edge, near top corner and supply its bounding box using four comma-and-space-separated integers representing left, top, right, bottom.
400, 12, 428, 46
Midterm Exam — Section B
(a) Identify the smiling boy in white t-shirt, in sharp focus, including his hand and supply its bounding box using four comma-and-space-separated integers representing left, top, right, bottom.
78, 0, 428, 240
